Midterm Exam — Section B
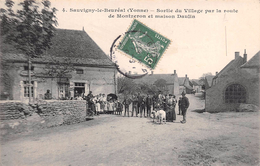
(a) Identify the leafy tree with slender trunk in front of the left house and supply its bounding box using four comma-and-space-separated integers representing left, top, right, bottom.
0, 0, 58, 102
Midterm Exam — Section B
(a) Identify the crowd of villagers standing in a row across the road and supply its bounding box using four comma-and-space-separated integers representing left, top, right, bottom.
85, 91, 189, 123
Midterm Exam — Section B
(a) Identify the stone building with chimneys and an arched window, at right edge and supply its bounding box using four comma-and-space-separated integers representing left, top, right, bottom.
205, 52, 260, 112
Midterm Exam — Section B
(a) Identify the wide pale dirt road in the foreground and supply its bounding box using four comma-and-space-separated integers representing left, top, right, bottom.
1, 95, 259, 166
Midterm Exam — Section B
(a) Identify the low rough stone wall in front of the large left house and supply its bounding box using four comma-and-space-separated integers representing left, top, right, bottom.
0, 100, 86, 135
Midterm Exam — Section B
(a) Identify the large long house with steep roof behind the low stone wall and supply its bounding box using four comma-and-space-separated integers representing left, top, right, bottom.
0, 29, 117, 102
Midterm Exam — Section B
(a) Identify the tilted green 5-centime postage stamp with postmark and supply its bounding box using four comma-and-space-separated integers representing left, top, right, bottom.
118, 20, 171, 69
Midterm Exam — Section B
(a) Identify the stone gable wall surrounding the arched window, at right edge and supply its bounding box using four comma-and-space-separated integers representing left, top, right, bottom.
205, 69, 259, 112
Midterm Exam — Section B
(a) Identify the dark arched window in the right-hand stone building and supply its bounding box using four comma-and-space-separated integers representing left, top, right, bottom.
225, 84, 246, 103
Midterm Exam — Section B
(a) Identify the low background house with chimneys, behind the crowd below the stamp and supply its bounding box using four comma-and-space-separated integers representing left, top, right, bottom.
134, 70, 179, 95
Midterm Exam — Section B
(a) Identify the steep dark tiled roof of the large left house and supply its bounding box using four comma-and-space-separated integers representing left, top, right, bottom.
2, 29, 114, 66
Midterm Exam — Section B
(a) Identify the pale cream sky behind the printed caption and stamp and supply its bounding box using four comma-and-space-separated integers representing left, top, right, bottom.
1, 0, 260, 79
